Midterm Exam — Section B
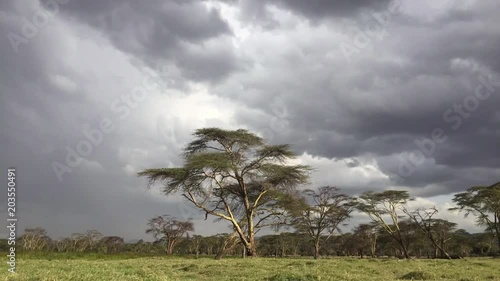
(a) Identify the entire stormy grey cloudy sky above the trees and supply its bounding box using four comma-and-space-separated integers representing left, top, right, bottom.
0, 0, 500, 239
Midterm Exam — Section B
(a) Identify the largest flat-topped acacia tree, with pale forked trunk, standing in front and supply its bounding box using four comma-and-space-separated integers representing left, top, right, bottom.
138, 128, 310, 257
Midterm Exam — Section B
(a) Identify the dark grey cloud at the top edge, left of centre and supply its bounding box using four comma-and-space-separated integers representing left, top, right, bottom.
62, 0, 240, 81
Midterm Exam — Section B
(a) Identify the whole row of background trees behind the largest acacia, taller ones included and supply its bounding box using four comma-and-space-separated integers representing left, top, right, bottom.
0, 180, 500, 259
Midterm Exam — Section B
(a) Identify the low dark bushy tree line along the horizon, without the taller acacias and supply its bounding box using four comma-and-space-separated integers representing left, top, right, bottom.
0, 221, 498, 258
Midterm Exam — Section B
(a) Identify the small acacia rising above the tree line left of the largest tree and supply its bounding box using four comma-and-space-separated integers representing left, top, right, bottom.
146, 215, 194, 255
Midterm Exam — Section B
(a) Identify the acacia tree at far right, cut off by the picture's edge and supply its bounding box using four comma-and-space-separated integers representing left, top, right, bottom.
450, 182, 500, 253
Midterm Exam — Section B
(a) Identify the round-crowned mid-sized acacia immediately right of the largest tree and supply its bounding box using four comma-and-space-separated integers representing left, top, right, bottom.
287, 186, 354, 259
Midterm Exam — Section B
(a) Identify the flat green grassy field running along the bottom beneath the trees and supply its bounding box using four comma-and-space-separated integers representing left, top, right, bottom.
0, 254, 500, 281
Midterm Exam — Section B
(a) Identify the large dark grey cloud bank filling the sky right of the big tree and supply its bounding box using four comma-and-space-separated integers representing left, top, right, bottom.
220, 1, 500, 192
